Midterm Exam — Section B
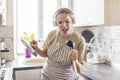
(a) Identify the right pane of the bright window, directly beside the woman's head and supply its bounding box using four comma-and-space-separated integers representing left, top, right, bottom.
42, 0, 57, 39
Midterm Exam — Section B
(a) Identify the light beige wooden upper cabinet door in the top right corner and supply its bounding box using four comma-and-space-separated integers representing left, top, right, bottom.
104, 0, 120, 24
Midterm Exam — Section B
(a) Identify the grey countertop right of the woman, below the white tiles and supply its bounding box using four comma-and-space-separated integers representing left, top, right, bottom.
81, 63, 120, 80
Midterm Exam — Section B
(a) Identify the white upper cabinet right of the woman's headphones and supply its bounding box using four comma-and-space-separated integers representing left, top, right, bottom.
73, 0, 104, 25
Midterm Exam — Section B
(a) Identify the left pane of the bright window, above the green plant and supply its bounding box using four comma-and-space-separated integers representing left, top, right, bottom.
16, 0, 38, 53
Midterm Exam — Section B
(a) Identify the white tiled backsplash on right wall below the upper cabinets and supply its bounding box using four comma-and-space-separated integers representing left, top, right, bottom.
76, 25, 120, 64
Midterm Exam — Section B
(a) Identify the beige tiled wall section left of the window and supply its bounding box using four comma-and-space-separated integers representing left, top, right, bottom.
0, 26, 14, 60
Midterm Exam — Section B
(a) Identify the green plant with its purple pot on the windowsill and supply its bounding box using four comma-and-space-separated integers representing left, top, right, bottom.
21, 32, 35, 57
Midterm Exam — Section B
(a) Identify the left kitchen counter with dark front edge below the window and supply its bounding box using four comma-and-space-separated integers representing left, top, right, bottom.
0, 55, 44, 80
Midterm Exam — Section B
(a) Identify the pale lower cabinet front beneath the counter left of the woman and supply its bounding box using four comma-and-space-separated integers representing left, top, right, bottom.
14, 69, 41, 80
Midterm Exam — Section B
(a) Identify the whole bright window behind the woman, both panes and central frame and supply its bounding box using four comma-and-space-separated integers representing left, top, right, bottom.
14, 0, 66, 53
